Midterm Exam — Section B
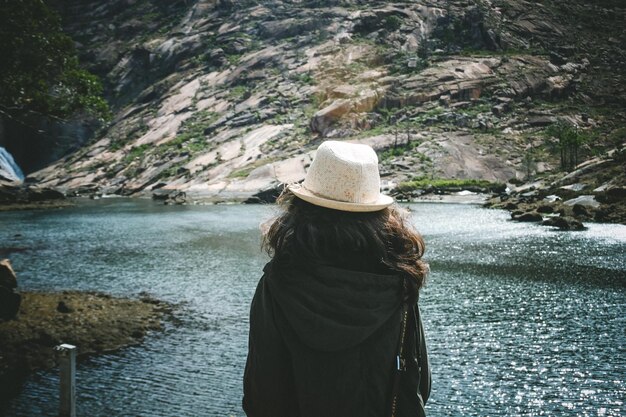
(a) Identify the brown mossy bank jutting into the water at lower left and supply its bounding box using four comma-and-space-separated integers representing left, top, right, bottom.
0, 291, 172, 398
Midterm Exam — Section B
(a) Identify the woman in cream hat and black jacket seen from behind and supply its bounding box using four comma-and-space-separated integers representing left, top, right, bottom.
243, 141, 430, 417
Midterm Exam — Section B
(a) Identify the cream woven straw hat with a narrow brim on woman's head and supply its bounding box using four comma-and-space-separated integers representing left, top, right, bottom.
289, 141, 393, 212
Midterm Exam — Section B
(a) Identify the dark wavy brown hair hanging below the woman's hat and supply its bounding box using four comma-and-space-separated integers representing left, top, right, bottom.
263, 189, 428, 298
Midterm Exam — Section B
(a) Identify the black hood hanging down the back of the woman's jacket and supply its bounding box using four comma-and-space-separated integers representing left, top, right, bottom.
265, 262, 403, 351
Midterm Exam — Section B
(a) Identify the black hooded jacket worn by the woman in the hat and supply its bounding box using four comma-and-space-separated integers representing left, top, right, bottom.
243, 262, 430, 417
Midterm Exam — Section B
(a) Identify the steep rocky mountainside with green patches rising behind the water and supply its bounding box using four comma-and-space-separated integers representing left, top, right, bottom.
6, 0, 626, 213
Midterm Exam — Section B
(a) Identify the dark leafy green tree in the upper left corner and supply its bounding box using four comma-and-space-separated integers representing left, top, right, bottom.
0, 0, 109, 121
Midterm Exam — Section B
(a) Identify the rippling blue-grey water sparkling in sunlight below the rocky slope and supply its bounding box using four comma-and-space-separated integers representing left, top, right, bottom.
0, 199, 626, 417
